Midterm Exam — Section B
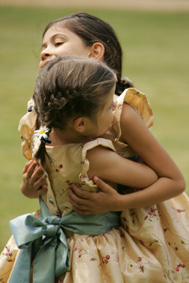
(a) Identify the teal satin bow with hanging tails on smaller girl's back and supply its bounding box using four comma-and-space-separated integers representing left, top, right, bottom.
9, 214, 69, 283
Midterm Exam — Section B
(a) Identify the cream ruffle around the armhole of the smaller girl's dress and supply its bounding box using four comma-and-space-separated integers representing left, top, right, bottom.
79, 138, 115, 191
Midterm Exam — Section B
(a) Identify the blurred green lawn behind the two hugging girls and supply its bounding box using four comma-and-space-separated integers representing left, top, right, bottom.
0, 7, 189, 250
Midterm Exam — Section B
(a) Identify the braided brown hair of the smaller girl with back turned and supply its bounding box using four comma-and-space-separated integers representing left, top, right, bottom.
33, 56, 116, 164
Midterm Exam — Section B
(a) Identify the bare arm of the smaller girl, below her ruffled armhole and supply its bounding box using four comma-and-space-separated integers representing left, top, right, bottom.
87, 146, 157, 189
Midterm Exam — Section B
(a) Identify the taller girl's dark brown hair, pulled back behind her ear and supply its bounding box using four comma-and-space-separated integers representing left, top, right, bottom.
43, 12, 133, 95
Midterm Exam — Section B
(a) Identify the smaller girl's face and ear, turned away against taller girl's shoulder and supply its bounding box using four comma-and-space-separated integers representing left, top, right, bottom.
86, 87, 116, 138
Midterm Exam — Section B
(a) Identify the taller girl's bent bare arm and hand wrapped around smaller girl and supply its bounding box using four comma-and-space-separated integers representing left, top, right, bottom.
69, 104, 185, 214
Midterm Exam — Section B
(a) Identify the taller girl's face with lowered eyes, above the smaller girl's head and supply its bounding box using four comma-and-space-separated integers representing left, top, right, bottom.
39, 23, 90, 69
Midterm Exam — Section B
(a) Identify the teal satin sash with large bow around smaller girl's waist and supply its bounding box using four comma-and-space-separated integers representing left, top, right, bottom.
9, 198, 120, 283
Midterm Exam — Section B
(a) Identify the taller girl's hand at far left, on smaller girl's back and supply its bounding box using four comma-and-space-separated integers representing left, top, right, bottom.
20, 160, 47, 198
